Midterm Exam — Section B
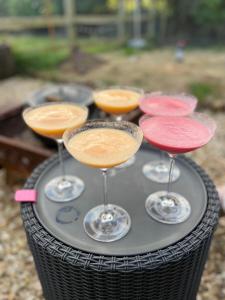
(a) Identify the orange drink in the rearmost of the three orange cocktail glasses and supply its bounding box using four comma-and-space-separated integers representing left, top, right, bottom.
94, 88, 141, 115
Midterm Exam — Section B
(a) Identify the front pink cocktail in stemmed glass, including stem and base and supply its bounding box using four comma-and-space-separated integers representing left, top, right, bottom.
140, 113, 216, 224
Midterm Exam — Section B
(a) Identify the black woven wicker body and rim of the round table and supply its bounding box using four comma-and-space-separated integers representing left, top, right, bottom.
21, 148, 219, 300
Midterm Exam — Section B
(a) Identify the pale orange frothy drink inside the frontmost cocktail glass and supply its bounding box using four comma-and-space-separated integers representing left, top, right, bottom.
67, 128, 140, 168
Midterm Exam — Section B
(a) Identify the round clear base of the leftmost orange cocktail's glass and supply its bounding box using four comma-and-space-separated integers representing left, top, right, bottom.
45, 175, 85, 202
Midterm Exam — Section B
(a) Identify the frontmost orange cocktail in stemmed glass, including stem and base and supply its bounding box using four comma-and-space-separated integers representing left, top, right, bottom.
63, 120, 143, 242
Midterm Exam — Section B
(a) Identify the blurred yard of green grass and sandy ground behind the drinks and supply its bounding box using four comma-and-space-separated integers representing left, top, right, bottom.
0, 35, 225, 108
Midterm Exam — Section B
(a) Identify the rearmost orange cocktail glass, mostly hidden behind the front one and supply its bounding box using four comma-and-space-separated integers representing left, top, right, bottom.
94, 86, 144, 169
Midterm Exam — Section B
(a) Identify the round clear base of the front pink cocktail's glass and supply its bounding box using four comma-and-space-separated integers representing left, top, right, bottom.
145, 191, 191, 224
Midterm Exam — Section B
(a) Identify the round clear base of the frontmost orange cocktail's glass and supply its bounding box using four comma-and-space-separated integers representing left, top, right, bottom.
84, 204, 131, 242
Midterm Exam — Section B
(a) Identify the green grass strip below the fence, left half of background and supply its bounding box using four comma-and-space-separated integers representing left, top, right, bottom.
0, 35, 122, 74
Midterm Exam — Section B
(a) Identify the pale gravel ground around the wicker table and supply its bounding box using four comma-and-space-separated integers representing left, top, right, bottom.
0, 78, 225, 300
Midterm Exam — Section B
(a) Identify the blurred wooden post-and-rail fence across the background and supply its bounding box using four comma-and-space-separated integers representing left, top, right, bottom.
0, 0, 165, 44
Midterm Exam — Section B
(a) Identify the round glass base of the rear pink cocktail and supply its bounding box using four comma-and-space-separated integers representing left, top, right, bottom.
142, 160, 180, 183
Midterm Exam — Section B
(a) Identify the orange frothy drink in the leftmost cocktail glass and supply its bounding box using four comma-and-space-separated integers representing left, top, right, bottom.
23, 102, 88, 139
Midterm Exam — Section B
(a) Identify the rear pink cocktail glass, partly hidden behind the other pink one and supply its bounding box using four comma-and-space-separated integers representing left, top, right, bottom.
140, 92, 197, 183
